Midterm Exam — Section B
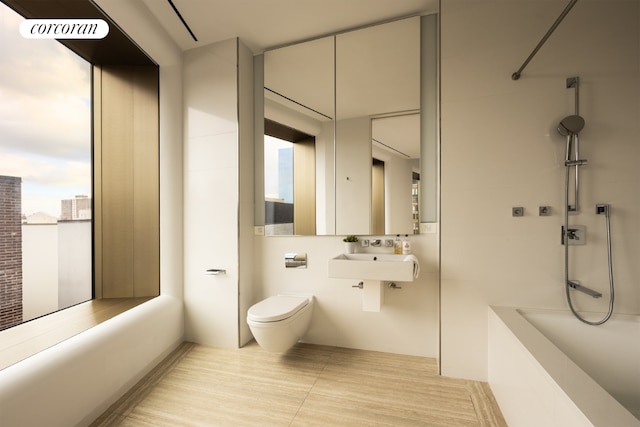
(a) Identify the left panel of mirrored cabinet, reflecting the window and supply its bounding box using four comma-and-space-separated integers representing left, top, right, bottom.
264, 37, 335, 236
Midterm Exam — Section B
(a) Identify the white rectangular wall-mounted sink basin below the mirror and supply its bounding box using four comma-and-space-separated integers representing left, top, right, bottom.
328, 254, 414, 282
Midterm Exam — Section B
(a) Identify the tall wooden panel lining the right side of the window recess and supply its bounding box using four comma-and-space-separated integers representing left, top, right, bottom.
96, 66, 160, 298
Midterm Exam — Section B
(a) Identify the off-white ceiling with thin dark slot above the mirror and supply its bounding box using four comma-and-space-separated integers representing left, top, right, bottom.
141, 0, 438, 54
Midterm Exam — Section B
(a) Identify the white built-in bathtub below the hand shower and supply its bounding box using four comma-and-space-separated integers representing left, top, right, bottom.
488, 307, 640, 427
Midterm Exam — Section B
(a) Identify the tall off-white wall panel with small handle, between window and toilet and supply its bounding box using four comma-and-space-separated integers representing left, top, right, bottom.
183, 39, 240, 347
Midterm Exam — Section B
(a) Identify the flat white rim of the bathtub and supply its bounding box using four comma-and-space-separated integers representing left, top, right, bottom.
489, 306, 640, 427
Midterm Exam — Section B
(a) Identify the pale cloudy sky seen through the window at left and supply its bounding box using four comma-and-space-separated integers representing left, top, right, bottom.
0, 2, 91, 217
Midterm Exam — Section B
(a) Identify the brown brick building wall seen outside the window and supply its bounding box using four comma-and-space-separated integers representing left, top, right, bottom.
0, 176, 22, 330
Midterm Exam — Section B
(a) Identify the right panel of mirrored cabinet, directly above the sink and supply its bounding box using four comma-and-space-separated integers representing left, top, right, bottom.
335, 17, 420, 235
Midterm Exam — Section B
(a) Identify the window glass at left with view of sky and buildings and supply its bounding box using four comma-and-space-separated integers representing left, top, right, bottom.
0, 3, 93, 329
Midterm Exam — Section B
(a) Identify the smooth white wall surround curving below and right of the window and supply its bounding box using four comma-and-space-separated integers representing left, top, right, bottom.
0, 0, 184, 426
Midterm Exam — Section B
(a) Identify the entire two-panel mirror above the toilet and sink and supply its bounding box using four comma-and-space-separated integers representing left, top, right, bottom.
264, 17, 420, 235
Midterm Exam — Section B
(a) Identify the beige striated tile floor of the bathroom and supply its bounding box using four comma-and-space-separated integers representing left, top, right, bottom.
93, 343, 506, 427
